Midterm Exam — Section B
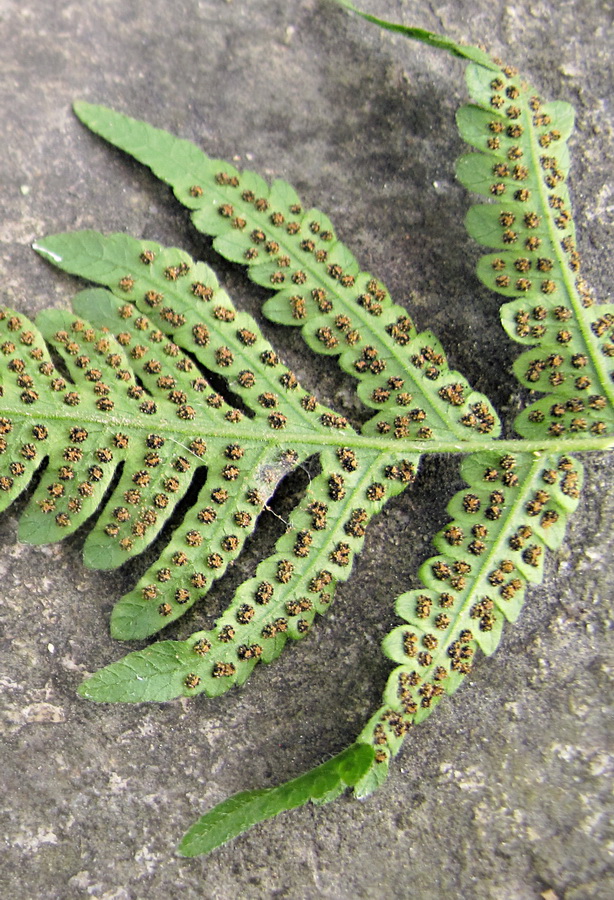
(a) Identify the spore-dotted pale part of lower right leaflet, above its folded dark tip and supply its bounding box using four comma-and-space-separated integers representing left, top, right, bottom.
356, 451, 583, 796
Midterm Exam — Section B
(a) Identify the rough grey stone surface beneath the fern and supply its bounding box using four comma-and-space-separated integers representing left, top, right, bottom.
0, 0, 614, 900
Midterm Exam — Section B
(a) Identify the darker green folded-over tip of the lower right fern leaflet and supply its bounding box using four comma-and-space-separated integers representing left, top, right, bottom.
179, 743, 373, 856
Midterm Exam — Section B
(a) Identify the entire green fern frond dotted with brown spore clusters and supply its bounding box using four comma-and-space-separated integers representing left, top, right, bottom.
0, 0, 614, 856
